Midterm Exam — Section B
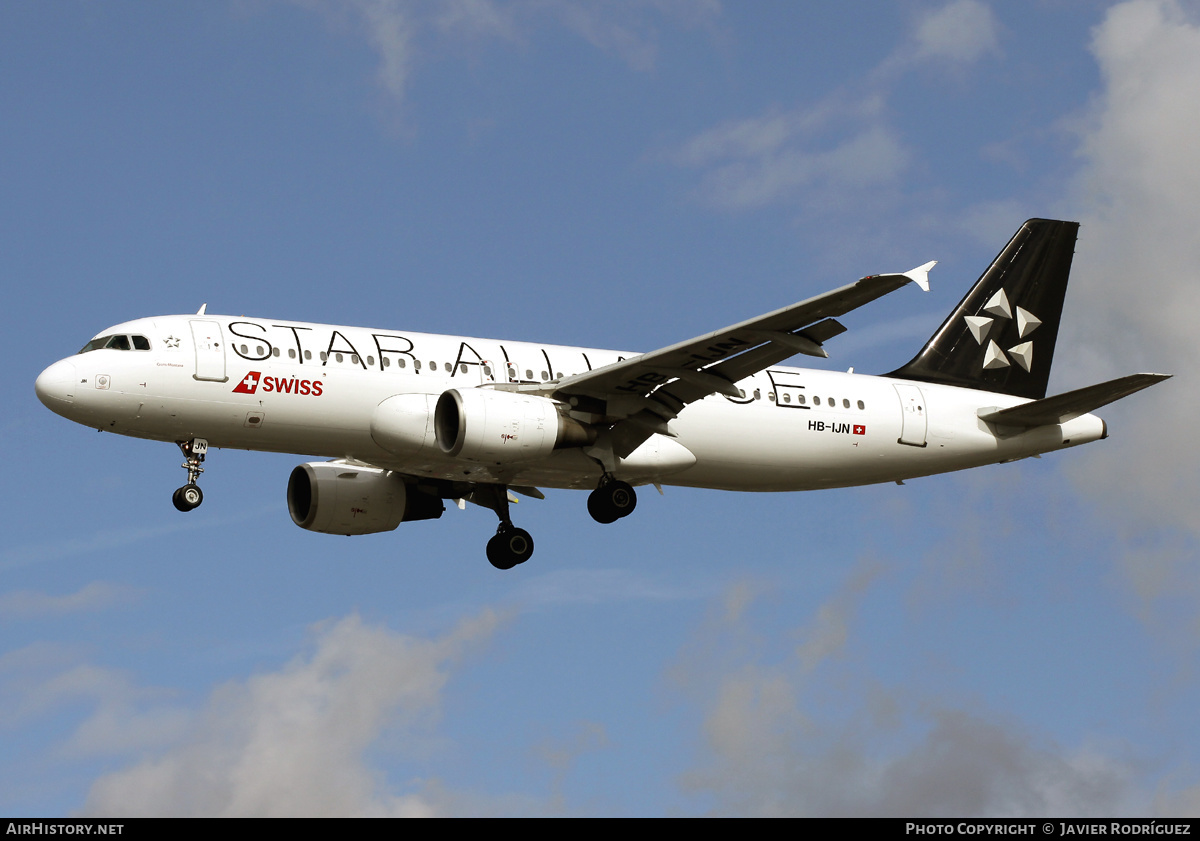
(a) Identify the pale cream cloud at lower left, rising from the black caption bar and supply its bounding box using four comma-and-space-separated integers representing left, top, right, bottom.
83, 612, 498, 816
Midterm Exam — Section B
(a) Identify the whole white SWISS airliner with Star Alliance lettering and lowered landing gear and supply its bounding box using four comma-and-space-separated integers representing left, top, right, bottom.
36, 218, 1168, 570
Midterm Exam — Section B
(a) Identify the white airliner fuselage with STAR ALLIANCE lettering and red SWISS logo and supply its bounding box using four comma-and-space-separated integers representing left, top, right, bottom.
37, 316, 1104, 491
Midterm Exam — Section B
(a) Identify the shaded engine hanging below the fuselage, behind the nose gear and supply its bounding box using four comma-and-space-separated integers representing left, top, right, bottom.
288, 462, 445, 534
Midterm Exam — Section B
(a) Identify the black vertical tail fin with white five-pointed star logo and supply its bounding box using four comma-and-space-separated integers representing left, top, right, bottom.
887, 220, 1079, 400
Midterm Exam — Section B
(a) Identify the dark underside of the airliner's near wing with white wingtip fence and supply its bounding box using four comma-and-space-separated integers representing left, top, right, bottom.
553, 260, 936, 436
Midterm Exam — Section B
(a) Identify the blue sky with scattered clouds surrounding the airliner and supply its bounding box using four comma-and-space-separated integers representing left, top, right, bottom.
0, 0, 1200, 816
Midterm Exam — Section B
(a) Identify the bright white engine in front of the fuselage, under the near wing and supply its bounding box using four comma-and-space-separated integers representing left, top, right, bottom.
433, 389, 596, 464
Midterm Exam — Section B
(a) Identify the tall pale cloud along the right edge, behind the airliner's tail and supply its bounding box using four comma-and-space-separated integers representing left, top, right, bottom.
1058, 0, 1200, 628
